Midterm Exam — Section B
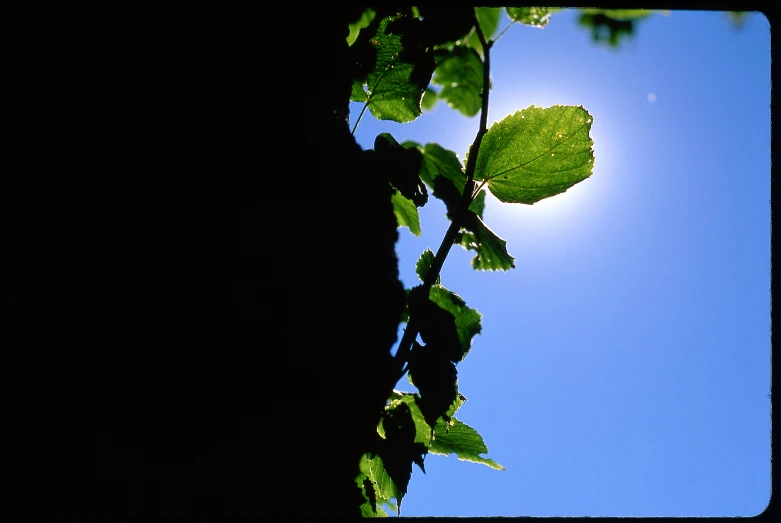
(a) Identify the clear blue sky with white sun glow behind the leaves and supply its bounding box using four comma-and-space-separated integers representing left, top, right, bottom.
351, 11, 771, 516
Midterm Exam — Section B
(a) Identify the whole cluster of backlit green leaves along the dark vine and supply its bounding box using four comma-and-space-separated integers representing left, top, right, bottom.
348, 7, 593, 516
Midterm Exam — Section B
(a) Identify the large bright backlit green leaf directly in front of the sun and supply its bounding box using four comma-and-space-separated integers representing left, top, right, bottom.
475, 105, 594, 204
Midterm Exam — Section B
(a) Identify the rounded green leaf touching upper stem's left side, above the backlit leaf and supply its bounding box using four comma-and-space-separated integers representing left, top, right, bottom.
432, 47, 483, 116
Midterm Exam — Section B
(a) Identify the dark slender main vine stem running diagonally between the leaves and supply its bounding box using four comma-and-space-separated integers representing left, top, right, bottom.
392, 11, 493, 386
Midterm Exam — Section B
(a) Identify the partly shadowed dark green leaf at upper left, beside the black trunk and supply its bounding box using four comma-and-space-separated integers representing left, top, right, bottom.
350, 17, 436, 123
